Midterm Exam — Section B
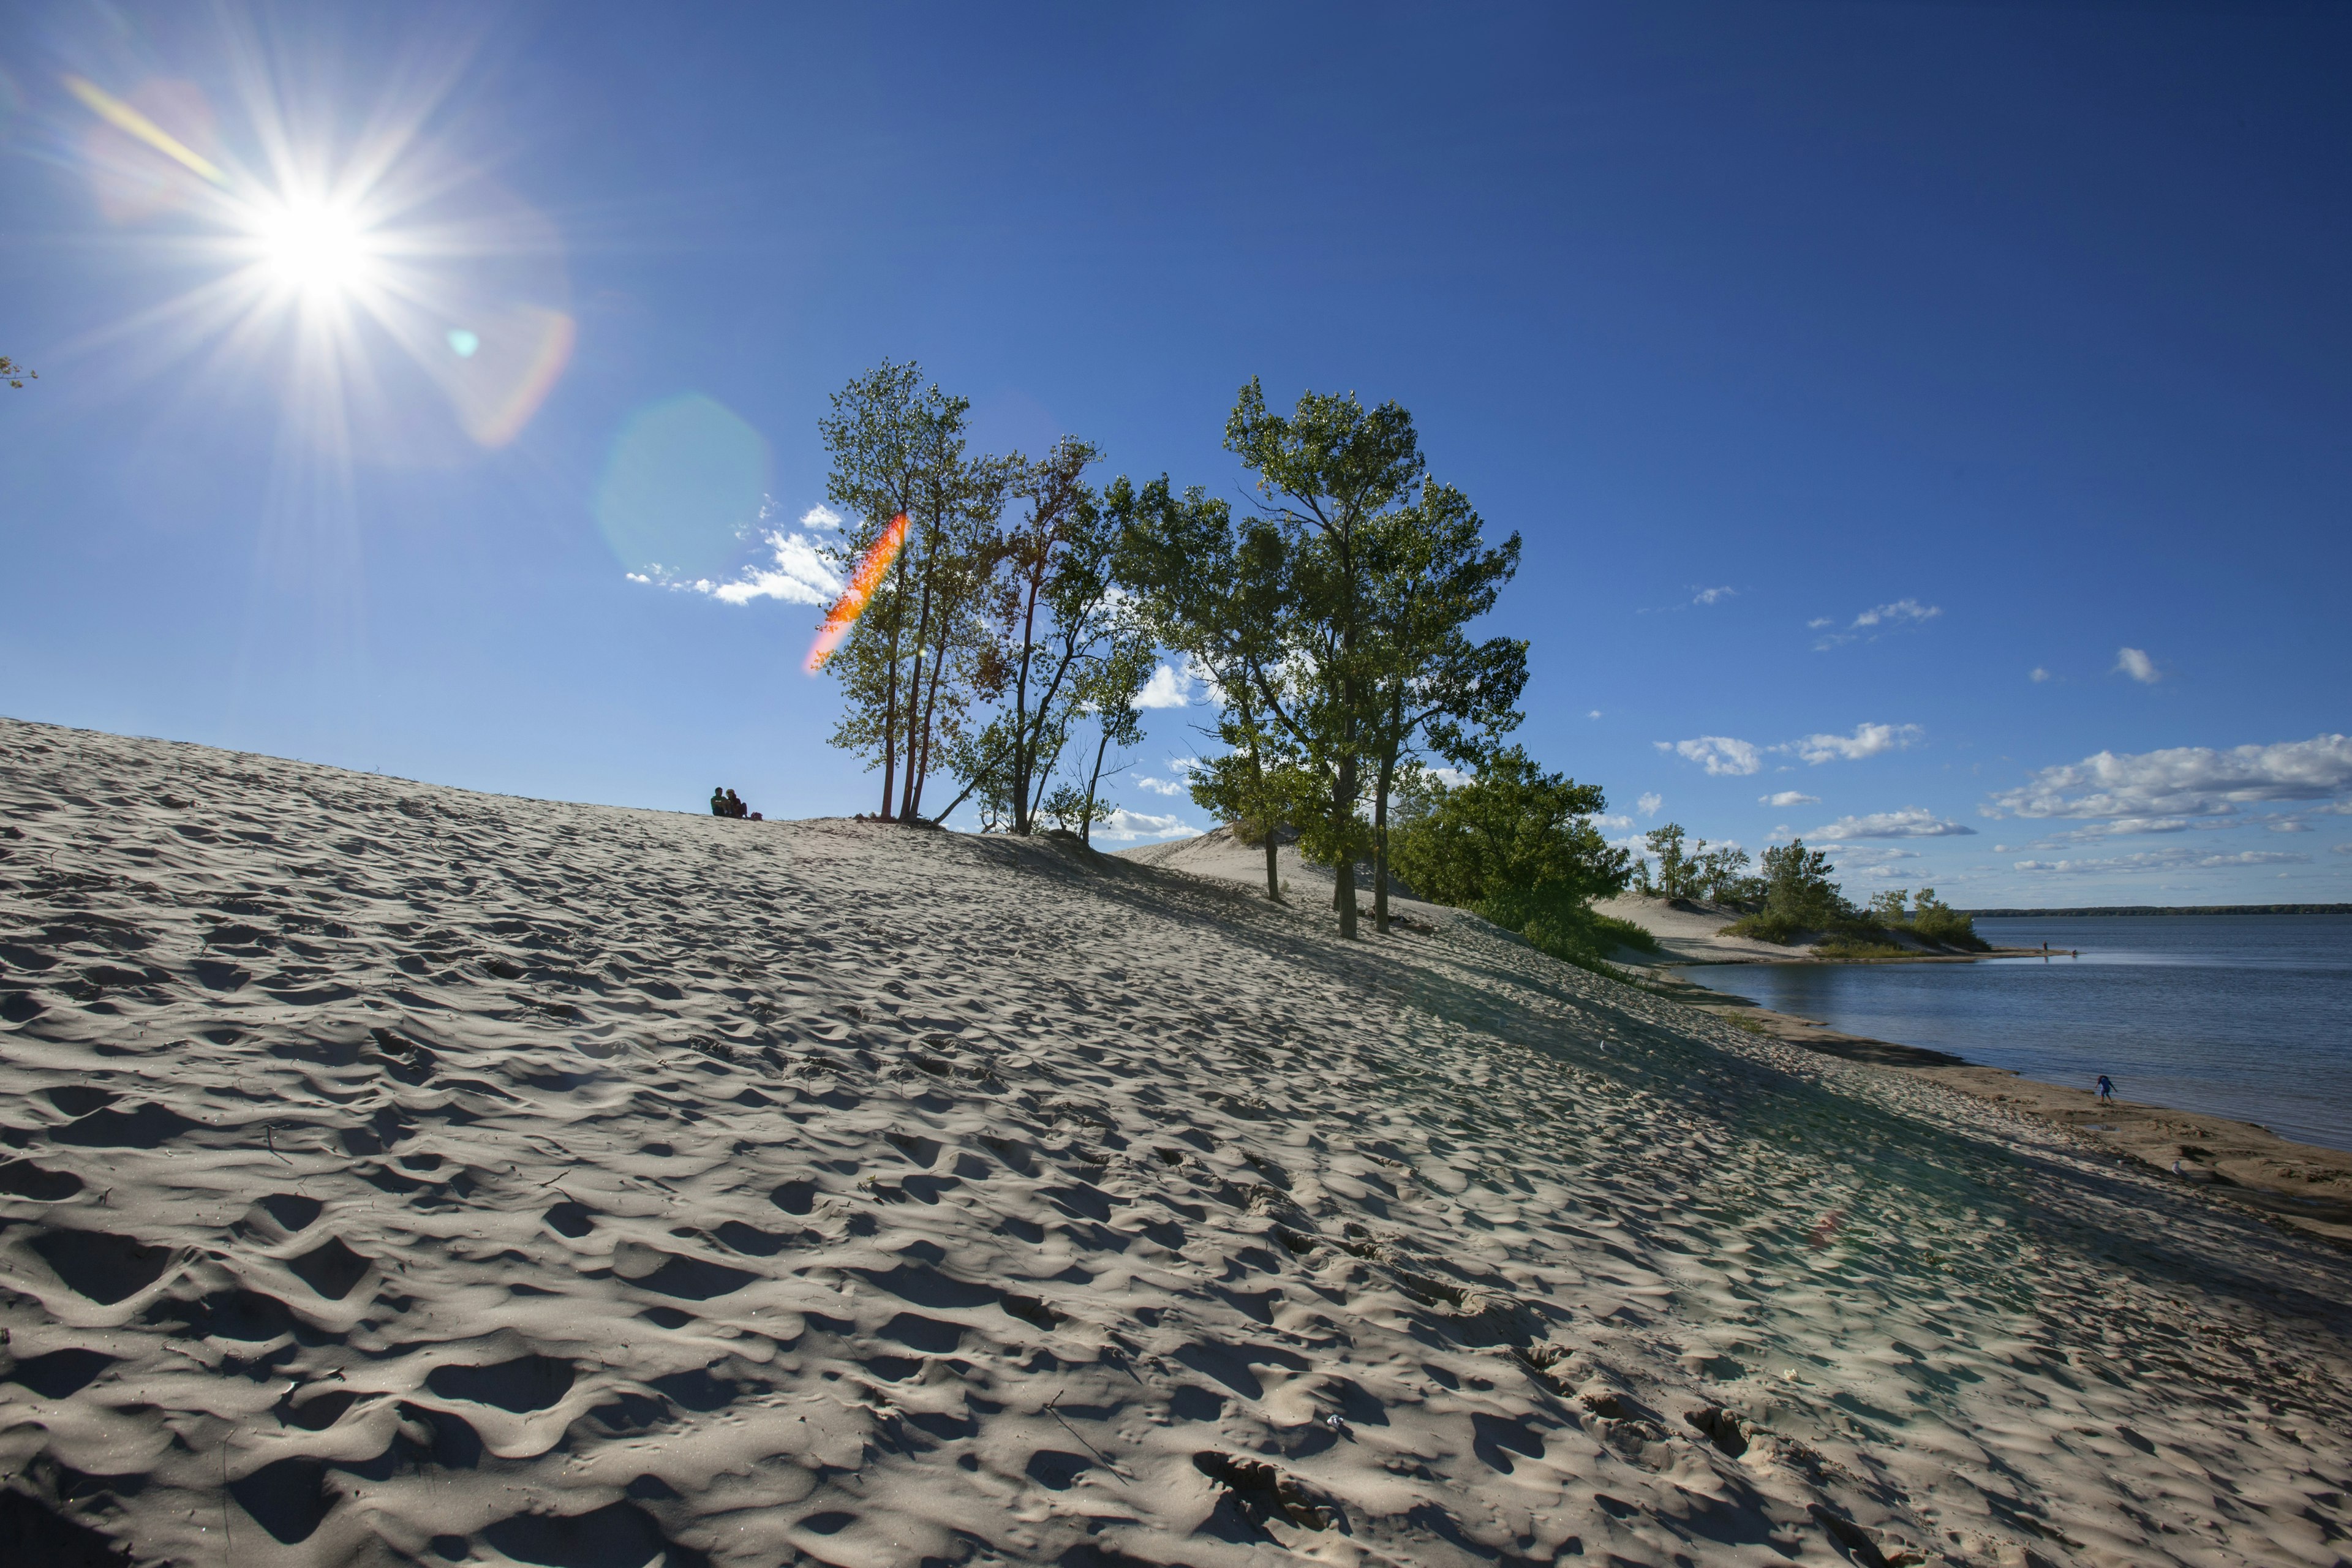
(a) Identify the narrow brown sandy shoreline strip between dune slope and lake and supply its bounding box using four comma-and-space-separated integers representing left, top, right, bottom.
1649, 968, 2352, 1251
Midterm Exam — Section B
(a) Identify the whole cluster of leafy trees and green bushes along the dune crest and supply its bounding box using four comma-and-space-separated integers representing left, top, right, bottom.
821, 362, 1639, 957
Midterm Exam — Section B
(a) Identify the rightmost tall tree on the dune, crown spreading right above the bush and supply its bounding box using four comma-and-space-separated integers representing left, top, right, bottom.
1364, 482, 1526, 936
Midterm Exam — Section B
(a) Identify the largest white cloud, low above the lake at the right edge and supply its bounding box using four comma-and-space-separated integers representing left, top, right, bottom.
1992, 736, 2352, 832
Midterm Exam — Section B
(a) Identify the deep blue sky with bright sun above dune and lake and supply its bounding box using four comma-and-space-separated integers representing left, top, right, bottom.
0, 0, 2352, 905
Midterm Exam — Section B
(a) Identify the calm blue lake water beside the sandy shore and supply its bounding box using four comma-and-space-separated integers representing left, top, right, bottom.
1684, 914, 2352, 1150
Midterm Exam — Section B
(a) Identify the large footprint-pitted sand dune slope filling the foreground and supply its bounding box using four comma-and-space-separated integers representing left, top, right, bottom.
0, 722, 2352, 1568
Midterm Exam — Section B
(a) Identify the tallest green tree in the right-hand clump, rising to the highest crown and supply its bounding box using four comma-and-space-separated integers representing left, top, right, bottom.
1226, 376, 1423, 940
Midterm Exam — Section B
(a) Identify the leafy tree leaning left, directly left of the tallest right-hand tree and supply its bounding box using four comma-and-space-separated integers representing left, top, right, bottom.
1103, 475, 1310, 903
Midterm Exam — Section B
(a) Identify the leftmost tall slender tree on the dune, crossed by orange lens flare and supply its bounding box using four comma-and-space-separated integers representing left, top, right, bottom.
818, 360, 1011, 823
